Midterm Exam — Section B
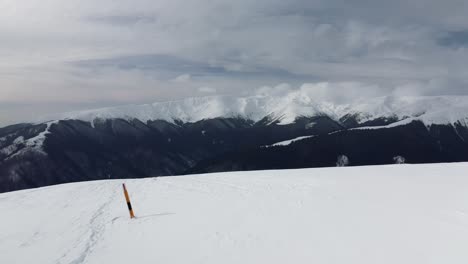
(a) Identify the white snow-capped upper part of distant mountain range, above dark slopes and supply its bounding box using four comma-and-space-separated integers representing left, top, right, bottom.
41, 94, 468, 128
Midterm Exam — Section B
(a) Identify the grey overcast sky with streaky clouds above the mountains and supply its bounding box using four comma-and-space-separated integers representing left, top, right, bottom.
0, 0, 468, 126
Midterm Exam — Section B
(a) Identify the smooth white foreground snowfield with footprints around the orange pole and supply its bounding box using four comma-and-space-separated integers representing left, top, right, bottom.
0, 163, 468, 264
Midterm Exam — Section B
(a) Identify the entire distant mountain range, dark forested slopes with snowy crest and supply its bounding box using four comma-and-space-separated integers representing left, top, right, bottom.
0, 97, 468, 192
